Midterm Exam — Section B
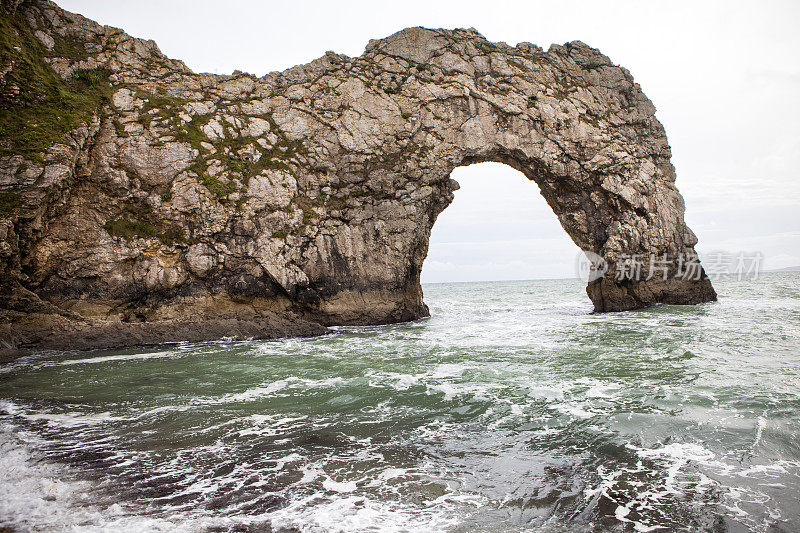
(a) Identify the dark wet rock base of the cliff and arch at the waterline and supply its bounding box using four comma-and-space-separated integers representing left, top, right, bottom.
0, 278, 717, 354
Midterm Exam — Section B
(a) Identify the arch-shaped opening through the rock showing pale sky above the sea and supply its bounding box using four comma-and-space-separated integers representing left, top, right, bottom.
421, 162, 581, 284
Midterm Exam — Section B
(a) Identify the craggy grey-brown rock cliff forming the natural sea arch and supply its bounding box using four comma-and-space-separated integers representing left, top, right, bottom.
0, 1, 715, 350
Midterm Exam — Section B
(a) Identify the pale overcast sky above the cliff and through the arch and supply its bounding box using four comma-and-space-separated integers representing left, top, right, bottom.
57, 0, 800, 282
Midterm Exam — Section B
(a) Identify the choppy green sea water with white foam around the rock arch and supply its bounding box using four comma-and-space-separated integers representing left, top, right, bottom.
0, 273, 800, 532
